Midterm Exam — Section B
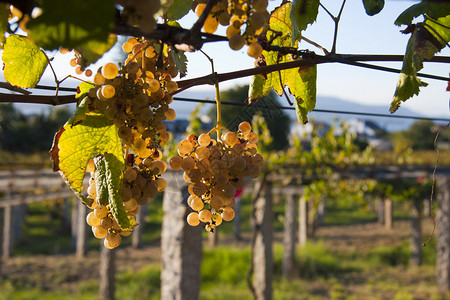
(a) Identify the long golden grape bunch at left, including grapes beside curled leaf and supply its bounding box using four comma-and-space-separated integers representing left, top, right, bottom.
82, 38, 178, 249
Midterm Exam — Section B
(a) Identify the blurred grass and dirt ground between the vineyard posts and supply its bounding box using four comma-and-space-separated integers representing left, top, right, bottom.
0, 193, 450, 300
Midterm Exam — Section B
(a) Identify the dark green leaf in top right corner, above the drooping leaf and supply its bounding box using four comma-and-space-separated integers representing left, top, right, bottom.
394, 1, 450, 26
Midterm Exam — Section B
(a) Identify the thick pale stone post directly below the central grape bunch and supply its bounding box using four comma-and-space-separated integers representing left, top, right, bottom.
161, 171, 202, 300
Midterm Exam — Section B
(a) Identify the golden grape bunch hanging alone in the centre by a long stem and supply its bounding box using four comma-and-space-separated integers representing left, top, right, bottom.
169, 122, 264, 232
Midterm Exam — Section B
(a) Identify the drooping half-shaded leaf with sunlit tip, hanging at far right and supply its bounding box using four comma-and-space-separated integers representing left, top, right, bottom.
389, 24, 443, 113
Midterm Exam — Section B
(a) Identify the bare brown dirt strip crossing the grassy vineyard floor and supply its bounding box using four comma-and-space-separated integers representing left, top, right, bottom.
1, 220, 440, 290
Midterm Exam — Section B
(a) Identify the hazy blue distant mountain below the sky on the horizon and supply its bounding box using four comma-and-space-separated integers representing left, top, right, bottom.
174, 90, 446, 131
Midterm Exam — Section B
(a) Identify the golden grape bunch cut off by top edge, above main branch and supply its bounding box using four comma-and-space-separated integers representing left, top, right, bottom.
195, 0, 269, 58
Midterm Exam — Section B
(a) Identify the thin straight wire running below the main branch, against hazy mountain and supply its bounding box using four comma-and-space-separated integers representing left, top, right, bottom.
173, 97, 450, 122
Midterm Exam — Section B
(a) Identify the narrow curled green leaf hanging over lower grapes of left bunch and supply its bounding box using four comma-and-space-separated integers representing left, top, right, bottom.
94, 153, 137, 230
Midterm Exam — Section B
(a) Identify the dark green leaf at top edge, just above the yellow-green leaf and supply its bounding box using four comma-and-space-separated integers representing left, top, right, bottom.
290, 0, 319, 44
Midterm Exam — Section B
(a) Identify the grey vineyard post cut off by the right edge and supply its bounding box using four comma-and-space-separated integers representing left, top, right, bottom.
436, 176, 450, 292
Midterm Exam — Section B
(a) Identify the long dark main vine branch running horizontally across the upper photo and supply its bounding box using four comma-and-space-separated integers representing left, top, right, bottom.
0, 53, 450, 105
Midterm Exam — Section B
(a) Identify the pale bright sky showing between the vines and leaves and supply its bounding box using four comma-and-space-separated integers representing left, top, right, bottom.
4, 0, 450, 118
